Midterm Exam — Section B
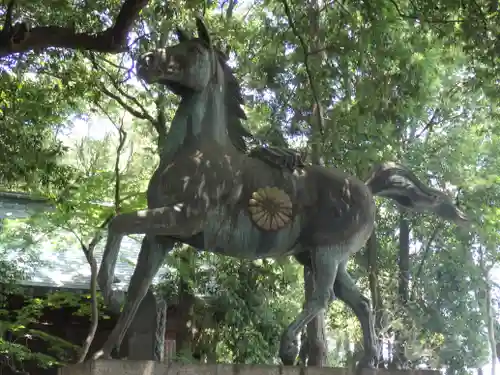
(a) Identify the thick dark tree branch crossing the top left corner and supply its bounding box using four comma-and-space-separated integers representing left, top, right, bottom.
0, 0, 148, 58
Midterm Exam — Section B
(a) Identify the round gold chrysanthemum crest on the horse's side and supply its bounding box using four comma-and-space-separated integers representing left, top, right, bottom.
248, 187, 292, 231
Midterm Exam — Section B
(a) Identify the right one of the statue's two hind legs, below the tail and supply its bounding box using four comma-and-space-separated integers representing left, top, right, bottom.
333, 262, 378, 369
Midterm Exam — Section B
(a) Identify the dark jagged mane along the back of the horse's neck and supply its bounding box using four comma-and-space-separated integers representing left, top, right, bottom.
215, 49, 254, 153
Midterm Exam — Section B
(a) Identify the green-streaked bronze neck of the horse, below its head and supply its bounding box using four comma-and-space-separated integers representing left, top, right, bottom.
162, 67, 230, 160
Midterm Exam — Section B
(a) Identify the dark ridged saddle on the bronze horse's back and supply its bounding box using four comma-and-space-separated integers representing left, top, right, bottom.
248, 146, 306, 172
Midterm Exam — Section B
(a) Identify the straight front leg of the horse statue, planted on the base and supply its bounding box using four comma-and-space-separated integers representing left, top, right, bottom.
94, 235, 176, 359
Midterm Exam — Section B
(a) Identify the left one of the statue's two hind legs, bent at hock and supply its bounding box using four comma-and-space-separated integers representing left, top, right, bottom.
279, 246, 339, 366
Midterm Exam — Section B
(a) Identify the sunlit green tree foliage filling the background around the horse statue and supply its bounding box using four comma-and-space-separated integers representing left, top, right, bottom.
0, 0, 500, 374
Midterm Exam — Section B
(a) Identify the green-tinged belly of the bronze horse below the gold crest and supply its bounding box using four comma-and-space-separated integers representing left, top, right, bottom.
204, 207, 300, 259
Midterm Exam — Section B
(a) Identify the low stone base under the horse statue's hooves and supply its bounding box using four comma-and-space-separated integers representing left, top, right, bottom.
59, 360, 440, 375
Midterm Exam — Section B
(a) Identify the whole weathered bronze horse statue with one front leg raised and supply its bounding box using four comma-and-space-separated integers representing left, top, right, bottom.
94, 18, 467, 367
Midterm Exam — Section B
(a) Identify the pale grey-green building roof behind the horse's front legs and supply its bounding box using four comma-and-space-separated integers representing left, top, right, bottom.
0, 192, 161, 289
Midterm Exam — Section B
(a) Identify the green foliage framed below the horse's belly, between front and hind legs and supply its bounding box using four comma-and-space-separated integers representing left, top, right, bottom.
159, 250, 301, 364
